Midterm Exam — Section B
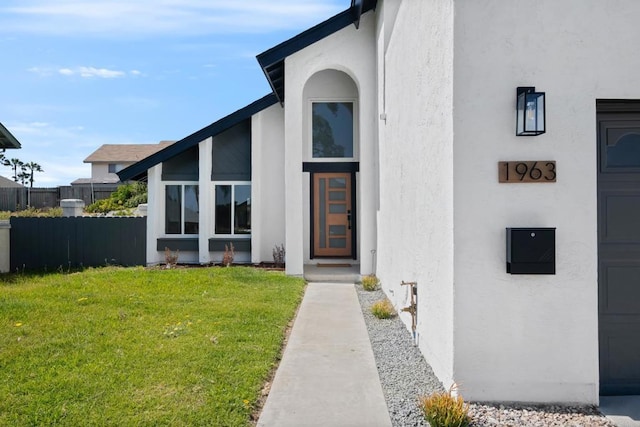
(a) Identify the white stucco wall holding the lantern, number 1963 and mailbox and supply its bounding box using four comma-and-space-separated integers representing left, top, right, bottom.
454, 0, 640, 403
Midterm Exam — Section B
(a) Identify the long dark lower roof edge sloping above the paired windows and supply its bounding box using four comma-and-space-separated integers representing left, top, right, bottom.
118, 93, 278, 182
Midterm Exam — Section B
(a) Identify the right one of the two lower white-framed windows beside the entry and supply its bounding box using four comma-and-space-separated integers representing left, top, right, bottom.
215, 184, 251, 235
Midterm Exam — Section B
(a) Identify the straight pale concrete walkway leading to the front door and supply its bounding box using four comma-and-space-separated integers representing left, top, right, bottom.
258, 283, 391, 427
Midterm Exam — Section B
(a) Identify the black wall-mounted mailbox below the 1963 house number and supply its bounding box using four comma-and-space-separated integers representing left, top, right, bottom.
507, 228, 556, 274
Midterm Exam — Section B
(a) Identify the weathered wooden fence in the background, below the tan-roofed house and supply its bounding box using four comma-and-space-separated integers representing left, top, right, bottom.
0, 185, 118, 212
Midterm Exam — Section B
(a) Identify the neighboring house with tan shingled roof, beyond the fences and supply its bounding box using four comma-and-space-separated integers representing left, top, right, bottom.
71, 141, 175, 185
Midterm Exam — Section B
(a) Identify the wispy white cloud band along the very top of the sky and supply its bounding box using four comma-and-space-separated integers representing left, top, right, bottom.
0, 0, 350, 38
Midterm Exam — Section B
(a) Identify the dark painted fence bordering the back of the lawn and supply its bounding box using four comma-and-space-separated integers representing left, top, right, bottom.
10, 217, 147, 271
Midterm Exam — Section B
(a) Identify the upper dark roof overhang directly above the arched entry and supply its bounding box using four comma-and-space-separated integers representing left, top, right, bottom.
257, 0, 377, 104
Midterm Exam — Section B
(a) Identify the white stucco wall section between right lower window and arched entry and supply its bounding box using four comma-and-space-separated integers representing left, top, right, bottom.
251, 104, 287, 263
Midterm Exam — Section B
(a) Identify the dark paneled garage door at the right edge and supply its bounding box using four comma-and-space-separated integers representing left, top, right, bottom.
598, 102, 640, 395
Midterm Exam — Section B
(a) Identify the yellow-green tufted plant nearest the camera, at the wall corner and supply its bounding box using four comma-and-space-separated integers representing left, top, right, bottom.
418, 384, 471, 427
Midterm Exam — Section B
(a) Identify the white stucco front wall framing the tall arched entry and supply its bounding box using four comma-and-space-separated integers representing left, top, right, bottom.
284, 13, 377, 275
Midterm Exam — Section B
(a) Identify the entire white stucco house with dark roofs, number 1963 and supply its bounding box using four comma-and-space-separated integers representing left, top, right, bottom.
119, 0, 640, 404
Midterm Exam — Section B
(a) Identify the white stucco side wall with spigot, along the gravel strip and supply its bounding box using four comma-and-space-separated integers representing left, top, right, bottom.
377, 0, 454, 387
